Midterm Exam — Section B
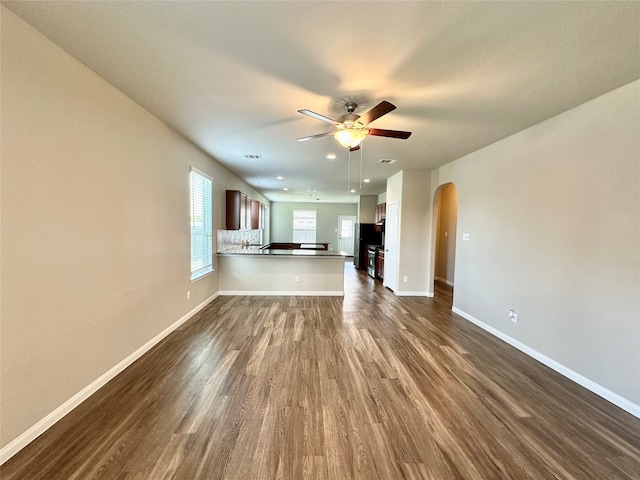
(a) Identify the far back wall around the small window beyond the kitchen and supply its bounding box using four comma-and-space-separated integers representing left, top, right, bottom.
271, 202, 358, 250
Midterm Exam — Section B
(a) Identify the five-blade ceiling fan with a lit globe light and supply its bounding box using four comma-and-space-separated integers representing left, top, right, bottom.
297, 101, 411, 151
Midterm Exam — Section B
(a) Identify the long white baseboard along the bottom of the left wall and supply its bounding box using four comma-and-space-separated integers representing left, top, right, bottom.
0, 293, 218, 465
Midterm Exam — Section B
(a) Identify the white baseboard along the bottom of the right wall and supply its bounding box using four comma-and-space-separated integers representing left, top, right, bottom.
451, 307, 640, 418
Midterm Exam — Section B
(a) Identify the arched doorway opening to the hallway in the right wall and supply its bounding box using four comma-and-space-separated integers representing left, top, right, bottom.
432, 183, 458, 305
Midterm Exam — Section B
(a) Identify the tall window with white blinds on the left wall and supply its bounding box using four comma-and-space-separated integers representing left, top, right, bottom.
189, 169, 213, 281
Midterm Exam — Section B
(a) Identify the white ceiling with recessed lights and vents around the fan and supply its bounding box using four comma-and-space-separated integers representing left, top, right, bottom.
2, 1, 640, 202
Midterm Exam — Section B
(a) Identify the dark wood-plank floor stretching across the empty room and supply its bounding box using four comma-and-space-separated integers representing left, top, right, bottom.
0, 265, 640, 480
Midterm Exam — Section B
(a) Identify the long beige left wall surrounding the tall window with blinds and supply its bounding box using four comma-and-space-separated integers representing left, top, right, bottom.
0, 7, 268, 446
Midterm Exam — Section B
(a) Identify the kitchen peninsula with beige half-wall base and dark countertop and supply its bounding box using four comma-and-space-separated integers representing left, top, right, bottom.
218, 246, 346, 296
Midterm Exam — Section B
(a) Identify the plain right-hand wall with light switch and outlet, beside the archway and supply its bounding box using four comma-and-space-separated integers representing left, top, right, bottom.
432, 81, 640, 406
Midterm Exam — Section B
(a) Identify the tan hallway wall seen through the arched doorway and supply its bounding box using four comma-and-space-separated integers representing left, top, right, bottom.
435, 183, 458, 286
